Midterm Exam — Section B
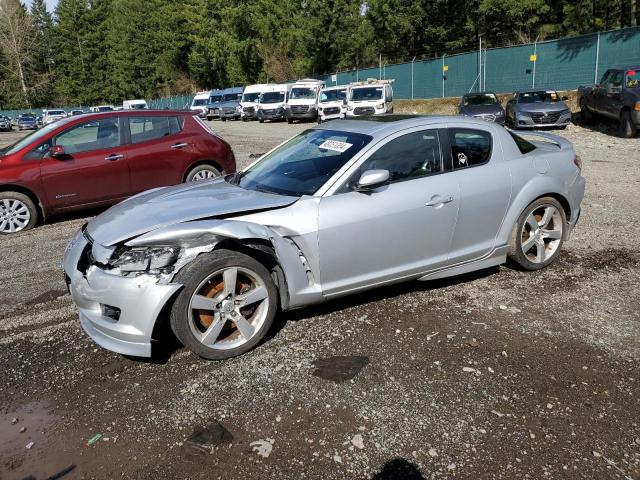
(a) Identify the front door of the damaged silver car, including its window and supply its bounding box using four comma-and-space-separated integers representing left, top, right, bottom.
318, 128, 458, 296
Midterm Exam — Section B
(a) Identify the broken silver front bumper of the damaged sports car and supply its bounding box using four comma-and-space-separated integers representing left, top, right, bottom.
63, 232, 181, 357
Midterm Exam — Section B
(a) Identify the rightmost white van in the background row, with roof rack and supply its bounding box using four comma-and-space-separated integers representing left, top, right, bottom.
347, 78, 393, 117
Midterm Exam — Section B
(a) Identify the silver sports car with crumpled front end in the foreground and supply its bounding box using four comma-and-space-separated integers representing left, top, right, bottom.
63, 116, 585, 359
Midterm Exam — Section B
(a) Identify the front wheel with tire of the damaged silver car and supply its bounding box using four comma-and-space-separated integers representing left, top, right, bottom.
170, 250, 278, 360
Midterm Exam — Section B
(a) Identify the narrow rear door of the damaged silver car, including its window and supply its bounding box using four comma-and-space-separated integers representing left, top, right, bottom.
446, 123, 511, 263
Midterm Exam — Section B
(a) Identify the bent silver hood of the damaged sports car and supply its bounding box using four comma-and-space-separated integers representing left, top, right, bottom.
87, 179, 298, 246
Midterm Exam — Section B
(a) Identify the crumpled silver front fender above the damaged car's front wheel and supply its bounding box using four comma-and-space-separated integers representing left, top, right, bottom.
126, 220, 323, 309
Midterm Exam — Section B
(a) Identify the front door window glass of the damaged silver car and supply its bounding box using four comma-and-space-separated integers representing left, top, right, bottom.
352, 129, 442, 182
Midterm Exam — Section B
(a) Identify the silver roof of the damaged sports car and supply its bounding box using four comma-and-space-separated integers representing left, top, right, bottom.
315, 114, 502, 137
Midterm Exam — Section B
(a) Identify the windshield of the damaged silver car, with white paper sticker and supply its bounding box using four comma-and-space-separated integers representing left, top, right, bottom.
235, 130, 371, 197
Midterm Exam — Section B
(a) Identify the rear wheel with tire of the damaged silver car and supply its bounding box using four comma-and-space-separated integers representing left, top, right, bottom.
508, 197, 567, 270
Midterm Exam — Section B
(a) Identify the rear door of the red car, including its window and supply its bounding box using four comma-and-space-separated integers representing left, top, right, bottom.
126, 115, 194, 193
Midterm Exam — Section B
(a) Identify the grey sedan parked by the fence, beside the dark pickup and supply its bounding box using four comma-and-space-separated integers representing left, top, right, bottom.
507, 89, 571, 128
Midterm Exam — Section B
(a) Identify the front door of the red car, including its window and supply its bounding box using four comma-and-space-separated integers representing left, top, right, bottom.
34, 116, 130, 209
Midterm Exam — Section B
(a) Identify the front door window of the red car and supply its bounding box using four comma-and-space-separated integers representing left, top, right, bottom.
54, 117, 120, 154
